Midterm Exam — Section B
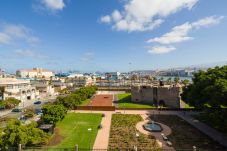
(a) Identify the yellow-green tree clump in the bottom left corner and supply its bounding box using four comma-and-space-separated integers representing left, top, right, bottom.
0, 120, 49, 149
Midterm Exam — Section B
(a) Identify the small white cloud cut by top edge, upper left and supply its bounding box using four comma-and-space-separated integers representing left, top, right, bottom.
41, 0, 65, 11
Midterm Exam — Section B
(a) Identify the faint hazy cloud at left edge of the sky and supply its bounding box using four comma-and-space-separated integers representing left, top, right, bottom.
0, 23, 39, 44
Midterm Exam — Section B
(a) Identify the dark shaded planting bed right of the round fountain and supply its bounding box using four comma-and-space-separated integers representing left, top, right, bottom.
154, 115, 224, 150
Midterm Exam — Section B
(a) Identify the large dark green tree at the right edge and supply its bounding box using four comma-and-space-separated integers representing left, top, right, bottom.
182, 66, 227, 107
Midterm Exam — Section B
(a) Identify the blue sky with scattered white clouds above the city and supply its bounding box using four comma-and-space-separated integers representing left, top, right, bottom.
0, 0, 227, 72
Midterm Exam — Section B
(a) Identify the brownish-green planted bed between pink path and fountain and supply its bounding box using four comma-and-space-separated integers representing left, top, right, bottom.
109, 114, 159, 150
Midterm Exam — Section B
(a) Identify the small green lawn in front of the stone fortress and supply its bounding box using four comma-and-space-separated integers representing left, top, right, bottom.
118, 93, 156, 108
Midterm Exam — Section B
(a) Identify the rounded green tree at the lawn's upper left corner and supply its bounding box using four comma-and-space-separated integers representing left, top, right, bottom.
42, 104, 67, 124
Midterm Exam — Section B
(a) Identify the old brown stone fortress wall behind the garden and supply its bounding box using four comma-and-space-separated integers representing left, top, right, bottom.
131, 85, 181, 108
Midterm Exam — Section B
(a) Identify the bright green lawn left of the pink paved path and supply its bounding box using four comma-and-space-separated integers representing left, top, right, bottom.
52, 113, 102, 149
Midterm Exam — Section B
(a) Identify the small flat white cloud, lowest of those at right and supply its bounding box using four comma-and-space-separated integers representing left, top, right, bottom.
148, 46, 176, 54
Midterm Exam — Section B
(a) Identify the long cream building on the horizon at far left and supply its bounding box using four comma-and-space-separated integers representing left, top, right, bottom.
16, 68, 54, 79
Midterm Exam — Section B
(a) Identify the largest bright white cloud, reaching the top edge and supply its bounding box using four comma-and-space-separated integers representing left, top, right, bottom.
100, 0, 198, 32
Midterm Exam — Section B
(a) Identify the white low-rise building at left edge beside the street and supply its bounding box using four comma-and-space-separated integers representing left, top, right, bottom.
0, 78, 39, 102
